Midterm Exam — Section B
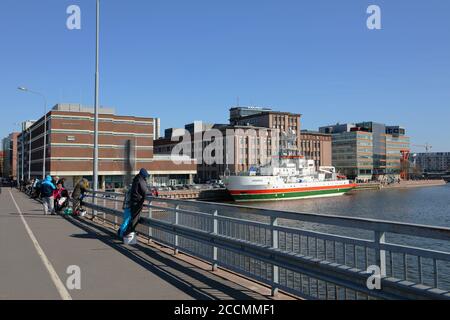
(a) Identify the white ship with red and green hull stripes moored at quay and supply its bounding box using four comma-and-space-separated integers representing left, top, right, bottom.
223, 156, 356, 202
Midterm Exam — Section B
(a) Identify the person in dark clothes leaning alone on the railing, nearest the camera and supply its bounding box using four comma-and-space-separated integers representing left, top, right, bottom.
119, 169, 150, 237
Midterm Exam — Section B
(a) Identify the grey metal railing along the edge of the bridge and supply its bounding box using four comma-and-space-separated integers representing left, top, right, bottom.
81, 192, 450, 300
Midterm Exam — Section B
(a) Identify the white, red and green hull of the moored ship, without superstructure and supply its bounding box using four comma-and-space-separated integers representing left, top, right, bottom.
226, 177, 356, 202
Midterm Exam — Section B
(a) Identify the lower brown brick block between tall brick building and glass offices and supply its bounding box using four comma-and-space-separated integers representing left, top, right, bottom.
300, 130, 332, 168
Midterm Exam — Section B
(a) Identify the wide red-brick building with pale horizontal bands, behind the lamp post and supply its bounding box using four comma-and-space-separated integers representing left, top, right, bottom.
18, 104, 196, 188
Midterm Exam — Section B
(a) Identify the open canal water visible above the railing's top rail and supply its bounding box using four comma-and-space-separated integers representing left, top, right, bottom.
246, 184, 450, 227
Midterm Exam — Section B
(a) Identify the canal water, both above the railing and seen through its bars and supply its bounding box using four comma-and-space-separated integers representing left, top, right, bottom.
143, 185, 450, 299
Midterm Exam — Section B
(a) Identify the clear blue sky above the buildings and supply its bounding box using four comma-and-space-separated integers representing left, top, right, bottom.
0, 0, 450, 151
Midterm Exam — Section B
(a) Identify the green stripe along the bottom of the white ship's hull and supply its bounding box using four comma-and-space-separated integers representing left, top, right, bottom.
232, 188, 353, 201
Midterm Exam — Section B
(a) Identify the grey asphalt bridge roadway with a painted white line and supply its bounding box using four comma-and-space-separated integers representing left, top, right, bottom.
0, 188, 266, 300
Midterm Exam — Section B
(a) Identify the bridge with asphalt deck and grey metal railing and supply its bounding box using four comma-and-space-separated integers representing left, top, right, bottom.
0, 188, 450, 300
